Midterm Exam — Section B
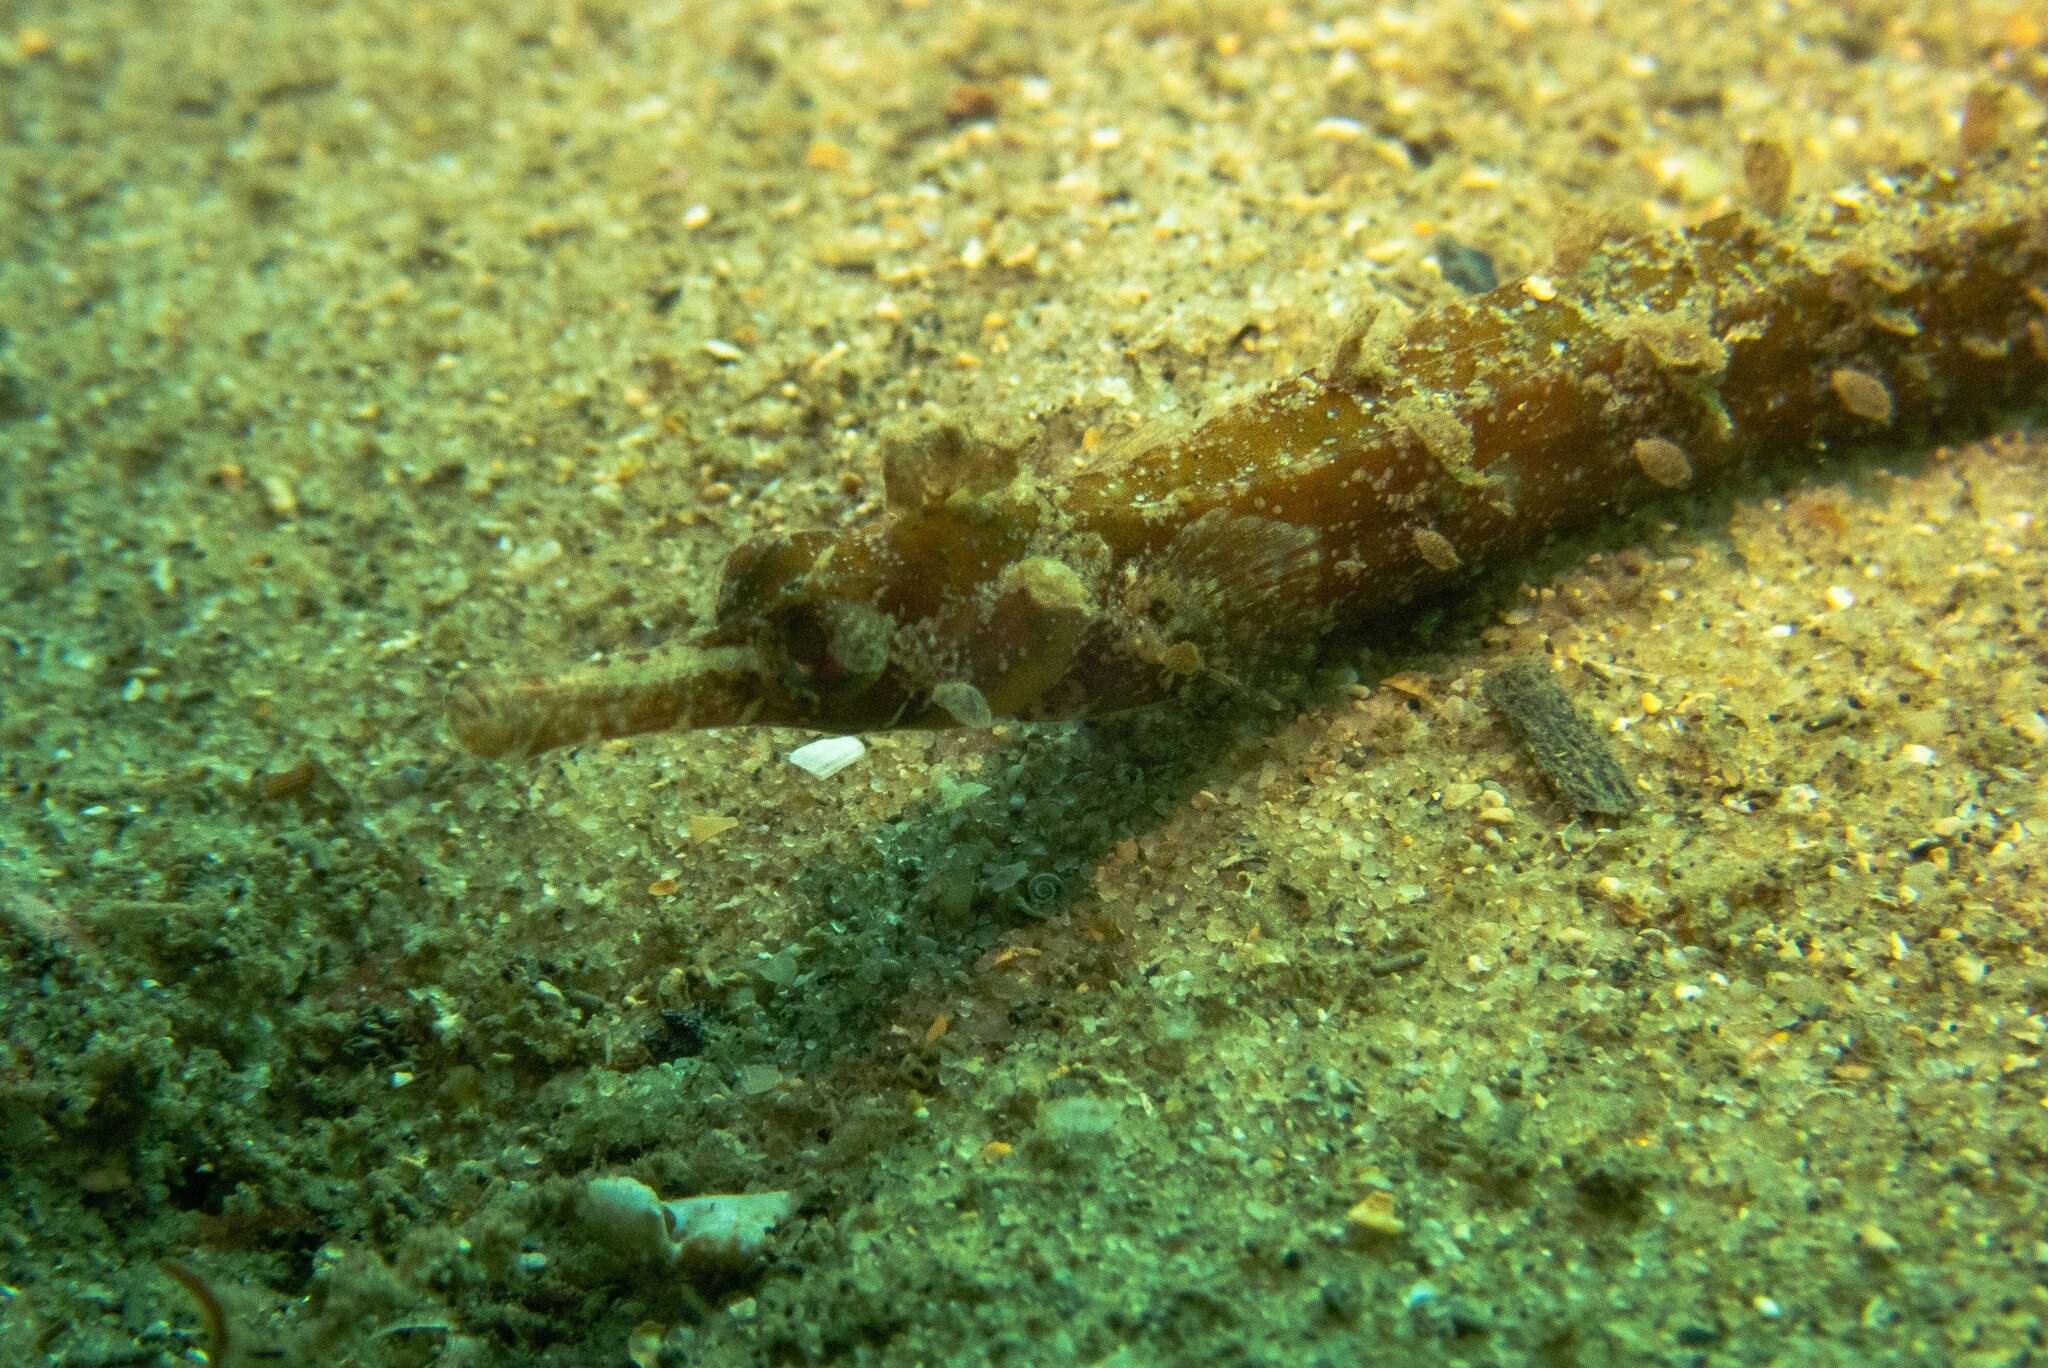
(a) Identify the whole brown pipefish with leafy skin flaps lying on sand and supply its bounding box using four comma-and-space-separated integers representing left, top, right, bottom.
449, 149, 2048, 756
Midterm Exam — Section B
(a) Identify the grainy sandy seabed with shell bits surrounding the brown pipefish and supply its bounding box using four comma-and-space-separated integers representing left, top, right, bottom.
0, 0, 2048, 1368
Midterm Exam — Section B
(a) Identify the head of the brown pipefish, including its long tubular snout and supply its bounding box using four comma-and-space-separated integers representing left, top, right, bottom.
449, 504, 1094, 756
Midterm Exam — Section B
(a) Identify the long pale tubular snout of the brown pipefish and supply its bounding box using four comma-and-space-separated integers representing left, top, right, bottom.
446, 645, 782, 758
